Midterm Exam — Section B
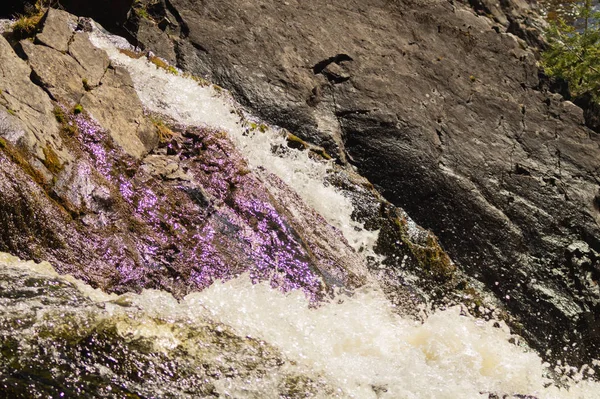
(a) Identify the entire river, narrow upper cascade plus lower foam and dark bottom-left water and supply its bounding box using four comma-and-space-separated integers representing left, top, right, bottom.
0, 22, 600, 399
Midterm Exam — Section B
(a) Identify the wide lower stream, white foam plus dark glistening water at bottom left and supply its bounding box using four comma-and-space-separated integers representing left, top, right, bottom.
0, 254, 599, 399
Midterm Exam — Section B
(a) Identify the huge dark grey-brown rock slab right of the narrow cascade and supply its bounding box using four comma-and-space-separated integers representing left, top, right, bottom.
116, 0, 600, 364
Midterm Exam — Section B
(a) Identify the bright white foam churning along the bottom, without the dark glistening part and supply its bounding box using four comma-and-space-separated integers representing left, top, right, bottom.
0, 254, 600, 399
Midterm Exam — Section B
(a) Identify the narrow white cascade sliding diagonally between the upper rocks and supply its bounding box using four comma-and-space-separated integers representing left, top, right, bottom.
91, 30, 378, 255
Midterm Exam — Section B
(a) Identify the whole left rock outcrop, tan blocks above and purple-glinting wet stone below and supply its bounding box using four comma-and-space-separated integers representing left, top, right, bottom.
0, 4, 456, 314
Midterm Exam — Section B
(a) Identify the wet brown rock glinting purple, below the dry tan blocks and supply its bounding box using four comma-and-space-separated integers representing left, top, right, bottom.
0, 98, 336, 299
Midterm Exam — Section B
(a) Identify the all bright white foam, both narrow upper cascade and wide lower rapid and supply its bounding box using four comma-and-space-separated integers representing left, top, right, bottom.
0, 24, 556, 399
